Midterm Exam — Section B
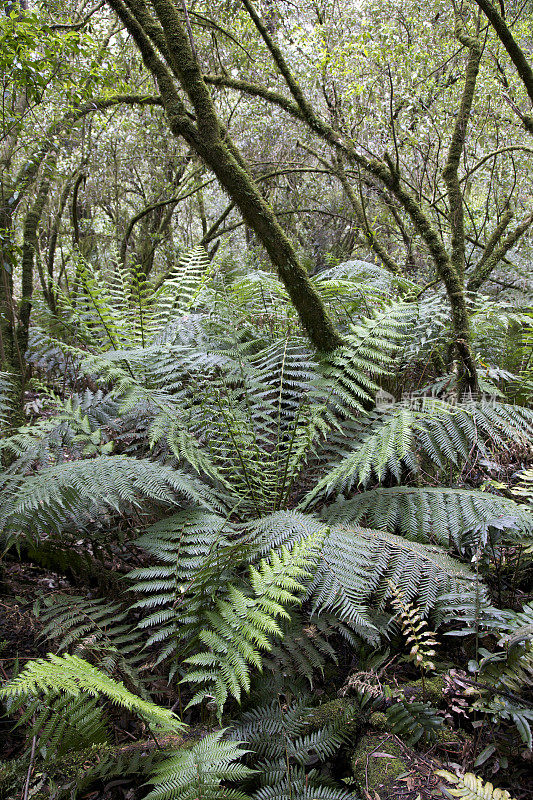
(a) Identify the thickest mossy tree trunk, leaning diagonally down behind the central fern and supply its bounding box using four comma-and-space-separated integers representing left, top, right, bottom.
103, 0, 342, 352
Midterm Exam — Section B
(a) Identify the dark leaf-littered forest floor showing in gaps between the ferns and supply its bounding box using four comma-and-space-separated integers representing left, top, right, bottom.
0, 418, 533, 800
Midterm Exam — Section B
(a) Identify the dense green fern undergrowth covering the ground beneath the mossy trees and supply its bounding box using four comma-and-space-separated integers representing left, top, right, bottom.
0, 249, 533, 800
